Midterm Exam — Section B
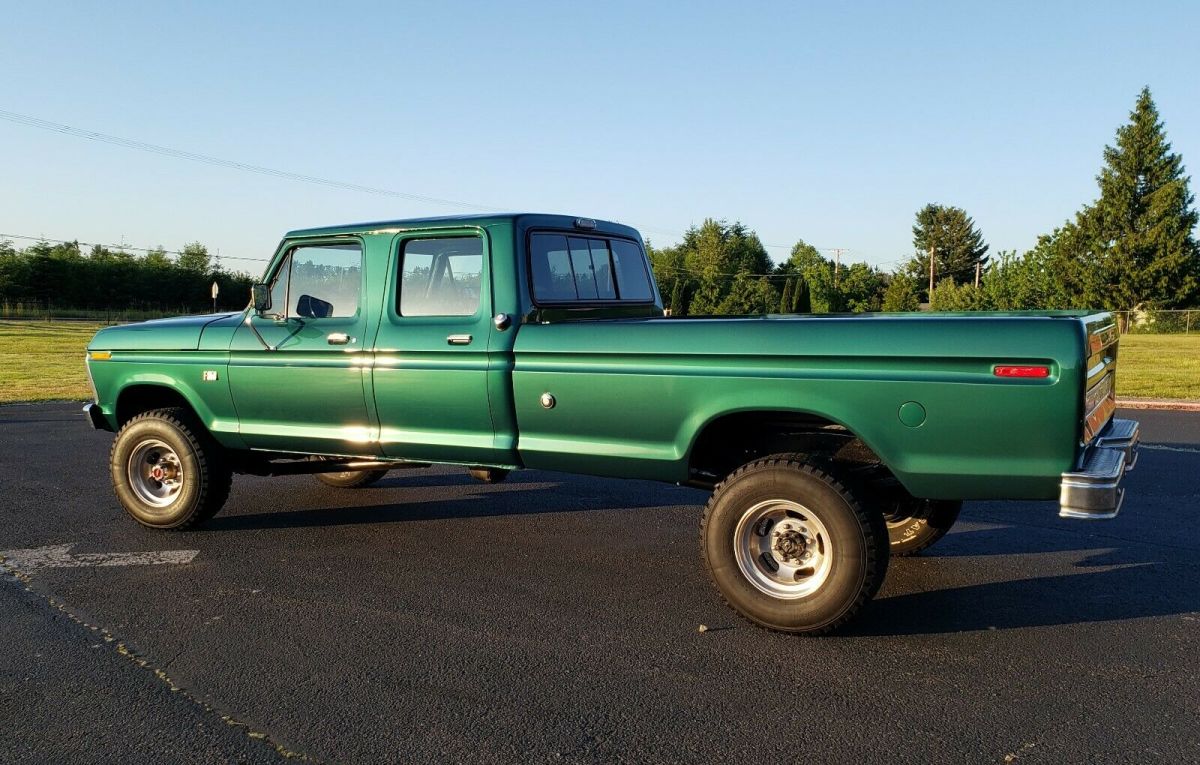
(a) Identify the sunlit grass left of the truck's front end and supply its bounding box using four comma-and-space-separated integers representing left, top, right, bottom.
0, 321, 100, 404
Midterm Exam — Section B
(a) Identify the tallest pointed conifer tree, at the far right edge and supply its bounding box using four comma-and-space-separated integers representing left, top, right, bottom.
1075, 88, 1200, 309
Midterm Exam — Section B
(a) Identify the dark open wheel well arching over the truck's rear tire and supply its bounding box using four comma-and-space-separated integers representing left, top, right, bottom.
688, 411, 894, 487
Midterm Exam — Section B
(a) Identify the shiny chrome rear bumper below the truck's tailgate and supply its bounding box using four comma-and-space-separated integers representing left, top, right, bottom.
1058, 418, 1138, 520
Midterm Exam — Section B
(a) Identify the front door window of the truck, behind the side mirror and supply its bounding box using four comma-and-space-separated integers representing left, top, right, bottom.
271, 242, 362, 319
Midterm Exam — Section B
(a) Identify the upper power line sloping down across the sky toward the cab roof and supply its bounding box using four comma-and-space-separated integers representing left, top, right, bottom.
0, 109, 883, 260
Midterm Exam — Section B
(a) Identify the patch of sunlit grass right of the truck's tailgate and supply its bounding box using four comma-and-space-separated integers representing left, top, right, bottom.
1117, 332, 1200, 400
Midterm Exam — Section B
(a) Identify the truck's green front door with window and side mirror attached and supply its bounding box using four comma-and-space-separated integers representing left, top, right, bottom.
229, 237, 378, 456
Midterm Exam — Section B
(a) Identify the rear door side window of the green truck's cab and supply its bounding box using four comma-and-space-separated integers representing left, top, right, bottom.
396, 236, 484, 317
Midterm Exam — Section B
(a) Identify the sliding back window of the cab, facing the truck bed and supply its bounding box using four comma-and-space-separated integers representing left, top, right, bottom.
529, 234, 654, 303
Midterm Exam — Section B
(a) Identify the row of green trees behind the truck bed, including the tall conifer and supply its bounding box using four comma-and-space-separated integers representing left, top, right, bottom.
648, 89, 1200, 315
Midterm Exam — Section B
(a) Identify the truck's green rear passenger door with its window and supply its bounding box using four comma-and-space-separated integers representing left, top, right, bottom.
373, 229, 516, 465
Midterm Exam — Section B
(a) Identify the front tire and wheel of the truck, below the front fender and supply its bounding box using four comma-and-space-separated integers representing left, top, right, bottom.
109, 408, 233, 529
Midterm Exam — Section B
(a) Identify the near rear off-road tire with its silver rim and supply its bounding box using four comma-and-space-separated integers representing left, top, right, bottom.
700, 454, 888, 636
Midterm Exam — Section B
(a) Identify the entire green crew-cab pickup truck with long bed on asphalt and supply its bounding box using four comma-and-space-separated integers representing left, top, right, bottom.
84, 215, 1138, 634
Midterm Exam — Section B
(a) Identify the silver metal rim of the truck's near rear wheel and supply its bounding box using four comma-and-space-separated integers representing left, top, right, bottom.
733, 499, 833, 600
